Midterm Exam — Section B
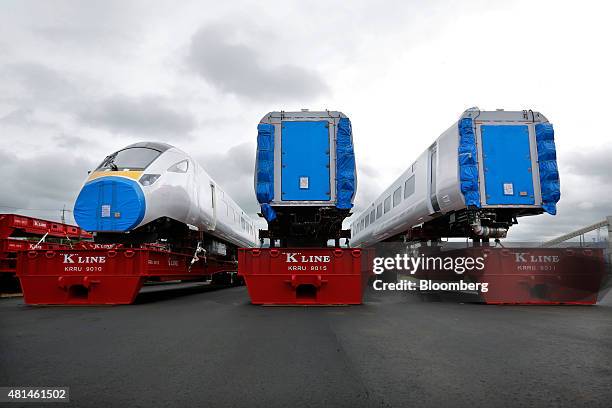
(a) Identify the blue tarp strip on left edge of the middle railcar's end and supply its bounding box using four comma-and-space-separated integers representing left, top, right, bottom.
255, 123, 276, 222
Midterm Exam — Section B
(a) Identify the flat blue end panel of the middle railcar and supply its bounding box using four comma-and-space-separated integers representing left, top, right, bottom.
281, 121, 331, 201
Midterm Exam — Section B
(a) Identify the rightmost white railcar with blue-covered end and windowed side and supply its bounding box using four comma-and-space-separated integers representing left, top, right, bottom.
351, 108, 560, 246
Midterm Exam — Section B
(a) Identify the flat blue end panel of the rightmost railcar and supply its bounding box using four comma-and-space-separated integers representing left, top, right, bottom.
480, 125, 535, 205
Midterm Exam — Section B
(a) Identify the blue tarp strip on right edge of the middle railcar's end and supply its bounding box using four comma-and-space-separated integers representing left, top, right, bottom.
336, 118, 357, 209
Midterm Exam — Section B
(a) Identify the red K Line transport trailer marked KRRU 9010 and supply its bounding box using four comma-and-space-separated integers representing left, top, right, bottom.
17, 248, 236, 305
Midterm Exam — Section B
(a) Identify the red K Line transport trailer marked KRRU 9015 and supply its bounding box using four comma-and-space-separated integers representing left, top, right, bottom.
238, 248, 373, 305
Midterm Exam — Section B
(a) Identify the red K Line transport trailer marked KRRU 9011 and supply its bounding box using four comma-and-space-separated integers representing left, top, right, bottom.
415, 248, 608, 305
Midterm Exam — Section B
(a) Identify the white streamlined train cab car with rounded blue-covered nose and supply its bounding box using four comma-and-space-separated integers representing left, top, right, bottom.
74, 142, 257, 252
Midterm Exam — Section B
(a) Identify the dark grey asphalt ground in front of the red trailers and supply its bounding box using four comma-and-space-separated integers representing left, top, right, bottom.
0, 284, 612, 408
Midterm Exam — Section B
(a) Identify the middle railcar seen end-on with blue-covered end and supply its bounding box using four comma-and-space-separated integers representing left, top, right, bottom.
255, 110, 357, 246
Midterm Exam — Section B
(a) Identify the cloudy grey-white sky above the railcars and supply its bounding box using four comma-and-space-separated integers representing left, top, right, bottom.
0, 0, 612, 239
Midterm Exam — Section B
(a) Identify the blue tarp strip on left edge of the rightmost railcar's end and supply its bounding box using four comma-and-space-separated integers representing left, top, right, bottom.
459, 118, 480, 207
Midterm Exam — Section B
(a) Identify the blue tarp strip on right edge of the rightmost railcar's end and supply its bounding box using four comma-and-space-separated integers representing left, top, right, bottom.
535, 123, 561, 215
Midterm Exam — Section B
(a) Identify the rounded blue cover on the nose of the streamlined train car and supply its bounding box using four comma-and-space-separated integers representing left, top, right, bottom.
74, 176, 146, 232
